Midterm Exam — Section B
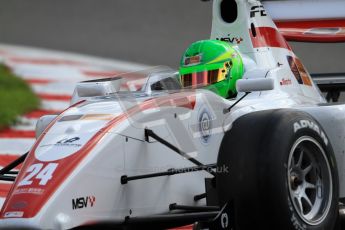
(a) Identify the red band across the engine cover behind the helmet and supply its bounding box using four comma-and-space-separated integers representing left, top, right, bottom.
249, 27, 291, 50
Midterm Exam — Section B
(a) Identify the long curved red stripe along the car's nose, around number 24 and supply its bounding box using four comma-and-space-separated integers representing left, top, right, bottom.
1, 92, 196, 218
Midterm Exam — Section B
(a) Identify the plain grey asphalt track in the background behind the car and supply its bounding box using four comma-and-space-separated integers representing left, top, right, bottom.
0, 0, 345, 73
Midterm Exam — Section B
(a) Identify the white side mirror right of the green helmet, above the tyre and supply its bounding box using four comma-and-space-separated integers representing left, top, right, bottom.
236, 78, 274, 93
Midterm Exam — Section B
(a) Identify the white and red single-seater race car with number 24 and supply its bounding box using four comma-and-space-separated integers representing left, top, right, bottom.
0, 0, 345, 230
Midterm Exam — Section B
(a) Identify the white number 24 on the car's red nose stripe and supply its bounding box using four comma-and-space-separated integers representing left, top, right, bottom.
18, 163, 58, 186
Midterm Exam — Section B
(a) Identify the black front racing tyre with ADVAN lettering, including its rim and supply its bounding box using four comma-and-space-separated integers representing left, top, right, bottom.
216, 109, 339, 230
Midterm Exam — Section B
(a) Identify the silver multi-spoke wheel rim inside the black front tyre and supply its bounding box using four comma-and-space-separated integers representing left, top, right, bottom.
288, 136, 333, 225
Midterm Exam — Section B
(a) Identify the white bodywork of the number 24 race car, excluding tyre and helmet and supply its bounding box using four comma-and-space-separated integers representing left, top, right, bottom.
0, 0, 345, 229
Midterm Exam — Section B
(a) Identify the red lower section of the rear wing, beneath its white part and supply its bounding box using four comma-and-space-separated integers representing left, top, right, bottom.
275, 19, 345, 42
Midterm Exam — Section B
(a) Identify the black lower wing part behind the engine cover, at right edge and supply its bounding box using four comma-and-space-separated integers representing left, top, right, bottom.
311, 73, 345, 102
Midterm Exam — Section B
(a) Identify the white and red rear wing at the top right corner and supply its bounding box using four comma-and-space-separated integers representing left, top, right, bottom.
262, 0, 345, 43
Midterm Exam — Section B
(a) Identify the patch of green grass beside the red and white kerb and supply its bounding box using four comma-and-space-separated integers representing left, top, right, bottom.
0, 64, 40, 130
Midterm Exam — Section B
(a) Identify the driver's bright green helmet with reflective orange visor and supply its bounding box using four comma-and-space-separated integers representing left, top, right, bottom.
179, 40, 243, 98
